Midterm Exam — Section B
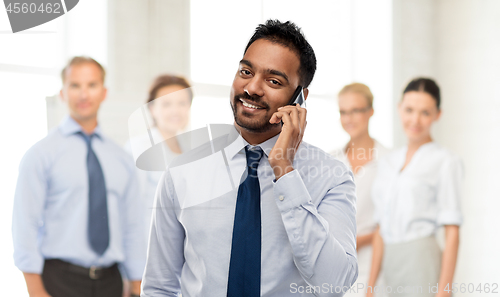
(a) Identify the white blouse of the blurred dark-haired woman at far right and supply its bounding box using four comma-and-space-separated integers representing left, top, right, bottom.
372, 142, 463, 244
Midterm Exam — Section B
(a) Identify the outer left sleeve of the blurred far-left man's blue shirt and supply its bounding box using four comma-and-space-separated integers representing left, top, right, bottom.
12, 147, 48, 274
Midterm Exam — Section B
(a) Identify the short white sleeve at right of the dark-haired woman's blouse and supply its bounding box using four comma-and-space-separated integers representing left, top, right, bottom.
437, 156, 464, 226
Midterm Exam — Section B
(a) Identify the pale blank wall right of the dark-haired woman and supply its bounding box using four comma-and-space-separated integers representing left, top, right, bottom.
435, 0, 500, 286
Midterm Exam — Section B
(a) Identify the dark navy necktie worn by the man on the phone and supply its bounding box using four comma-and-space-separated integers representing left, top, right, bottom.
227, 147, 263, 297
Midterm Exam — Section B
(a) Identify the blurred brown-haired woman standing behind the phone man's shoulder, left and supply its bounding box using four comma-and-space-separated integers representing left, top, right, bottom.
125, 74, 193, 231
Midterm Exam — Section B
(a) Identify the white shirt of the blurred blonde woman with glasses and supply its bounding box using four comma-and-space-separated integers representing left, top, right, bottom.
331, 140, 389, 297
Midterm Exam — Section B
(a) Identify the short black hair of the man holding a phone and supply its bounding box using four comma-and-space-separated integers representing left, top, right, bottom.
244, 20, 316, 88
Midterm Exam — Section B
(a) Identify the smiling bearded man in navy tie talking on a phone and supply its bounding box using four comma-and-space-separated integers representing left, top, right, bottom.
141, 20, 358, 297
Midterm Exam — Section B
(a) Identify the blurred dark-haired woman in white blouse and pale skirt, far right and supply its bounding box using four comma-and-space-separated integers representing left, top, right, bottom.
368, 78, 463, 297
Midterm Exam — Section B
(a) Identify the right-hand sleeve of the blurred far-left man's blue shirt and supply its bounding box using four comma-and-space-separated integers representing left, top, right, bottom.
123, 162, 147, 280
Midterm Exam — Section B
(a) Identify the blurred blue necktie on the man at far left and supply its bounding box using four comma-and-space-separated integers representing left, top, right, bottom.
80, 132, 109, 255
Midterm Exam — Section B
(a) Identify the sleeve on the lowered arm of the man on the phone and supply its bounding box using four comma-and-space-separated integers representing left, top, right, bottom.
141, 171, 185, 297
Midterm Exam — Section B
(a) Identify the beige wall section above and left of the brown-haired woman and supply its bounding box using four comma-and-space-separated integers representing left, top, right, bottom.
105, 0, 189, 144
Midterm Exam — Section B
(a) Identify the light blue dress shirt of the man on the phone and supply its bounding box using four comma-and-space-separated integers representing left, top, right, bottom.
141, 128, 358, 297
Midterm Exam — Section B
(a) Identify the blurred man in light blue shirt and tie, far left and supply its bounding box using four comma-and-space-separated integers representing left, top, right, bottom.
12, 57, 146, 297
